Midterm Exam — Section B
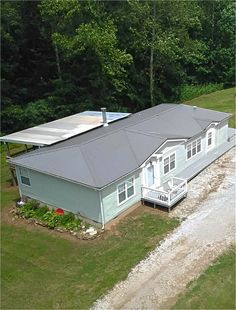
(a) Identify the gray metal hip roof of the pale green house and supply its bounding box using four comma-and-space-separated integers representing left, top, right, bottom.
11, 104, 230, 188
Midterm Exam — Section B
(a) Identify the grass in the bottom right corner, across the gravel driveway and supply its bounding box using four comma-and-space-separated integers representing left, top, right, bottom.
173, 249, 236, 309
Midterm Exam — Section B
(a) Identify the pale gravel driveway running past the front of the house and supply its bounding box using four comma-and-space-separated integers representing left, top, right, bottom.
94, 148, 236, 310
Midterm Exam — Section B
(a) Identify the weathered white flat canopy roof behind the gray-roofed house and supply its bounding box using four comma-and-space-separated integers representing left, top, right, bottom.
0, 111, 130, 146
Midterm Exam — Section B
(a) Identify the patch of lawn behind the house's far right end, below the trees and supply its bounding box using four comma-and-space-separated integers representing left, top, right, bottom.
187, 87, 236, 128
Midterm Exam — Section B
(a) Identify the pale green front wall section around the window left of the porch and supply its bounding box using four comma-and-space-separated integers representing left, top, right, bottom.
101, 171, 141, 223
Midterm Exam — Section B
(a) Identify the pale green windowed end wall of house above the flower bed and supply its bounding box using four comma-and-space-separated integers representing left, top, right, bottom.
16, 167, 101, 223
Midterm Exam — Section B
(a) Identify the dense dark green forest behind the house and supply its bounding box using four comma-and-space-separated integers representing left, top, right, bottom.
1, 0, 235, 133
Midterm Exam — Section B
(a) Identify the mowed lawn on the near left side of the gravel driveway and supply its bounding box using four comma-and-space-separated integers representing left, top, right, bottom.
1, 146, 178, 309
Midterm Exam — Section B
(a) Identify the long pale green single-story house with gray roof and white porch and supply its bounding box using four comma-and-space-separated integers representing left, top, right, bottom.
10, 104, 235, 226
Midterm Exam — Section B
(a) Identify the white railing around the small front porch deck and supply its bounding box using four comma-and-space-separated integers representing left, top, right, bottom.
142, 177, 188, 207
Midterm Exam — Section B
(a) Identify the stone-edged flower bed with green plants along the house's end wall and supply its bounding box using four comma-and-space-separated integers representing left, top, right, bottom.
16, 200, 97, 239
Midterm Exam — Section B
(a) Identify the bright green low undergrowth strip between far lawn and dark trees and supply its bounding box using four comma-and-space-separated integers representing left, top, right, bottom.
180, 83, 223, 102
